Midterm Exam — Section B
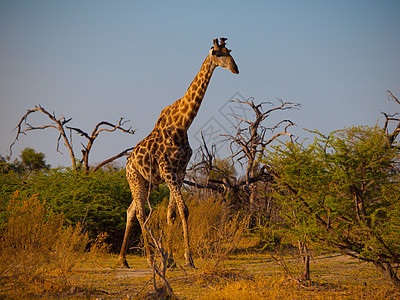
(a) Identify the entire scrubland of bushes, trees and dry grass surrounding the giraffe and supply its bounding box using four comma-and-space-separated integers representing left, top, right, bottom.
0, 94, 400, 299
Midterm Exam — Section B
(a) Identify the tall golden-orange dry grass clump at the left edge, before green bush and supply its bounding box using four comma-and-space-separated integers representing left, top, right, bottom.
0, 191, 89, 297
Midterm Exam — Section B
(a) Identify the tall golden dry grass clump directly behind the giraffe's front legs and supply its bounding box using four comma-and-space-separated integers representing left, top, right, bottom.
150, 195, 248, 264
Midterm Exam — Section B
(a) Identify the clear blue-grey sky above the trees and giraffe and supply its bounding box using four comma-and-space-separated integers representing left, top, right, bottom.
0, 0, 400, 166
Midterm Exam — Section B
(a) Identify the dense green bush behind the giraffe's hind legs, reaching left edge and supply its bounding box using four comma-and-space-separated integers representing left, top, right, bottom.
0, 168, 169, 252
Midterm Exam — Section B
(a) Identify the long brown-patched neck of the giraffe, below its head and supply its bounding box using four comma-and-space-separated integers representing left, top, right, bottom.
176, 55, 216, 130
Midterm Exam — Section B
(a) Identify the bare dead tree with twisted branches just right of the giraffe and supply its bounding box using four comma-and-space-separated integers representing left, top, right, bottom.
184, 98, 300, 224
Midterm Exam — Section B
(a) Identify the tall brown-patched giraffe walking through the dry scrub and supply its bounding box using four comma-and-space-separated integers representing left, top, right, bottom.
119, 38, 239, 268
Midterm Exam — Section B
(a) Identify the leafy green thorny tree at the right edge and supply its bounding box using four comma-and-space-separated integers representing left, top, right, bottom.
267, 127, 400, 288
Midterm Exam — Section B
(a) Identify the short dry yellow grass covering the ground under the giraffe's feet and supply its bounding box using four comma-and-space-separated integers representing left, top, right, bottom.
7, 254, 392, 300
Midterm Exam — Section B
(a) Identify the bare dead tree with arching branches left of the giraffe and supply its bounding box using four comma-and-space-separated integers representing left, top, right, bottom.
10, 105, 135, 172
